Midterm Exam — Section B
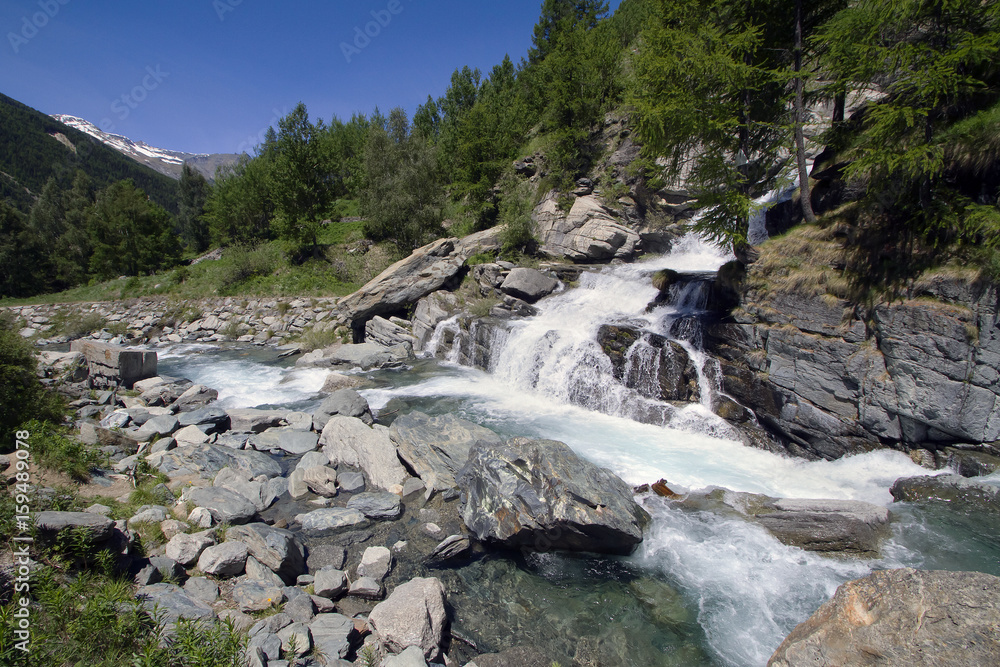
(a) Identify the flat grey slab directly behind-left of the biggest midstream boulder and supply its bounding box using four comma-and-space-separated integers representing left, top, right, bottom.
389, 412, 502, 497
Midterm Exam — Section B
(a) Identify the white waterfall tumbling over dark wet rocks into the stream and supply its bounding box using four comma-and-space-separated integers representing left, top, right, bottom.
425, 234, 730, 432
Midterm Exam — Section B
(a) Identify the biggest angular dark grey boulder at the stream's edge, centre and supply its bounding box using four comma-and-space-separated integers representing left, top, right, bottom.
457, 438, 649, 554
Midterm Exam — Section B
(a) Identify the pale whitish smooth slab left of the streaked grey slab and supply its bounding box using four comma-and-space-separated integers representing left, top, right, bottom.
319, 415, 408, 490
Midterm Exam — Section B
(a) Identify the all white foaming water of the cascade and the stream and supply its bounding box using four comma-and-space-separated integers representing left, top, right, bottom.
161, 232, 944, 666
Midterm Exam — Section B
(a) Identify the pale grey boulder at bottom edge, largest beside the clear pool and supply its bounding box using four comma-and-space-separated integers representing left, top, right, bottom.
368, 577, 448, 661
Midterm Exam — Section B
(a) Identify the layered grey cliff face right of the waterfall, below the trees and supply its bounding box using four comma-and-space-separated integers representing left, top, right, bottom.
707, 227, 1000, 464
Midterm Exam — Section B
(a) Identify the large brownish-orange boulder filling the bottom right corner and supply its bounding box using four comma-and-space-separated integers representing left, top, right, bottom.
768, 568, 1000, 667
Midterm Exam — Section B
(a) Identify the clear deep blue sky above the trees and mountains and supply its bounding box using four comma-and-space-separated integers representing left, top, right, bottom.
0, 0, 619, 153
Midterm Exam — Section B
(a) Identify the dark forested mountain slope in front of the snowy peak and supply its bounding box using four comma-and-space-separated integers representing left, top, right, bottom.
0, 94, 179, 213
